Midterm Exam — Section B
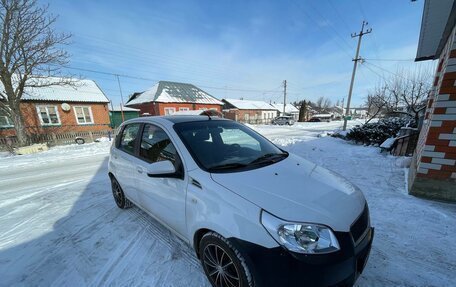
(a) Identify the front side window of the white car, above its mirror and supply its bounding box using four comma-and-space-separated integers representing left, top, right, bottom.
139, 124, 178, 165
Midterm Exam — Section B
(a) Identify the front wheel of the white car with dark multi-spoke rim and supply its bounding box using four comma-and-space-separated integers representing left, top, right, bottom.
199, 232, 254, 287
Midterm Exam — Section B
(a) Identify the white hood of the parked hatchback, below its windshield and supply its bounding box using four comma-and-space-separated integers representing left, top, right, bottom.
211, 154, 366, 232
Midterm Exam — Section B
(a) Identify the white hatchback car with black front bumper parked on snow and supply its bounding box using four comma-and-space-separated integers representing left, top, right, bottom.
109, 116, 374, 287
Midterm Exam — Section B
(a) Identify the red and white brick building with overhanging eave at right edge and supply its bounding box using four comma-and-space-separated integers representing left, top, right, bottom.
409, 0, 456, 201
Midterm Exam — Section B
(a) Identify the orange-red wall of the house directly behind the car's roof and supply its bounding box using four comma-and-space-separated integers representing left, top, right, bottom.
128, 103, 222, 116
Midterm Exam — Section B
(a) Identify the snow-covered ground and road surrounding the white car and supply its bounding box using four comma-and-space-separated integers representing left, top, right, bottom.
0, 122, 456, 287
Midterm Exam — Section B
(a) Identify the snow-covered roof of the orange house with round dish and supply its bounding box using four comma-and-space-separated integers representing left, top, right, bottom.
0, 77, 109, 103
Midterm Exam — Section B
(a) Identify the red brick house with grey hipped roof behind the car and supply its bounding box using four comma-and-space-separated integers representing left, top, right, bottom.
125, 81, 223, 116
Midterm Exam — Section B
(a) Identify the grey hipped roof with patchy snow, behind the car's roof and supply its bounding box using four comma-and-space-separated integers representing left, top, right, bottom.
126, 81, 223, 106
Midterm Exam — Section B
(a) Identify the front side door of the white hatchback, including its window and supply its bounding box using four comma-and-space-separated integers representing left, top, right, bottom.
136, 124, 186, 236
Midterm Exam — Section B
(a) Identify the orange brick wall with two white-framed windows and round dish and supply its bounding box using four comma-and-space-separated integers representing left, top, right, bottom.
0, 101, 110, 137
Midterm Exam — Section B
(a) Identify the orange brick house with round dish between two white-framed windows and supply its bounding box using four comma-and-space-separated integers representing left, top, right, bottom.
0, 78, 110, 143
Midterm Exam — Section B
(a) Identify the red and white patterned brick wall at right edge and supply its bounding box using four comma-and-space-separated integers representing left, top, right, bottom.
409, 24, 456, 201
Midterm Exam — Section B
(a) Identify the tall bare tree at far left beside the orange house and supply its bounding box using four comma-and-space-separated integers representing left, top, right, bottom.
0, 0, 71, 146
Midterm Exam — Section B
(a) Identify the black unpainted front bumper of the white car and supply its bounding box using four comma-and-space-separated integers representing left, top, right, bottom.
232, 227, 374, 287
